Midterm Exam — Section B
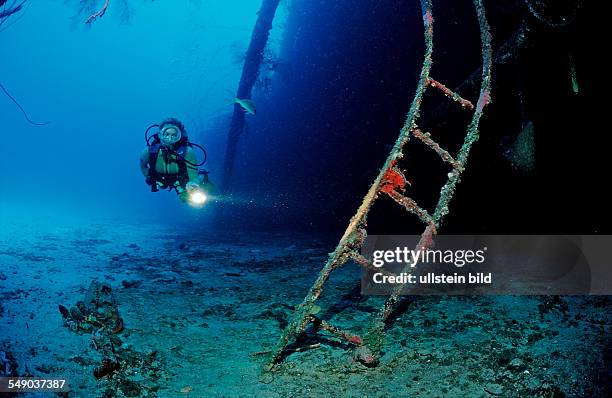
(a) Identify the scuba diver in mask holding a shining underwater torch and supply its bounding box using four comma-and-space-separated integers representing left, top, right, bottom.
140, 118, 213, 207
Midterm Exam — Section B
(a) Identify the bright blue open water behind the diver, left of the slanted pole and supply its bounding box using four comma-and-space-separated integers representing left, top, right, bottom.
0, 0, 284, 227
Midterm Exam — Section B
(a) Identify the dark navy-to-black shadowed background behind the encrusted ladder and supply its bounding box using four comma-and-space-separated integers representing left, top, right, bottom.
226, 0, 609, 234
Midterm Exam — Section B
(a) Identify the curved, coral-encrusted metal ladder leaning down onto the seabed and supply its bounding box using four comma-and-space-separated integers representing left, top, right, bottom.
265, 0, 491, 370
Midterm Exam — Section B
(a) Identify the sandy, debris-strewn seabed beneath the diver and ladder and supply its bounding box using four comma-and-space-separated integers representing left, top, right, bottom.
0, 222, 612, 397
